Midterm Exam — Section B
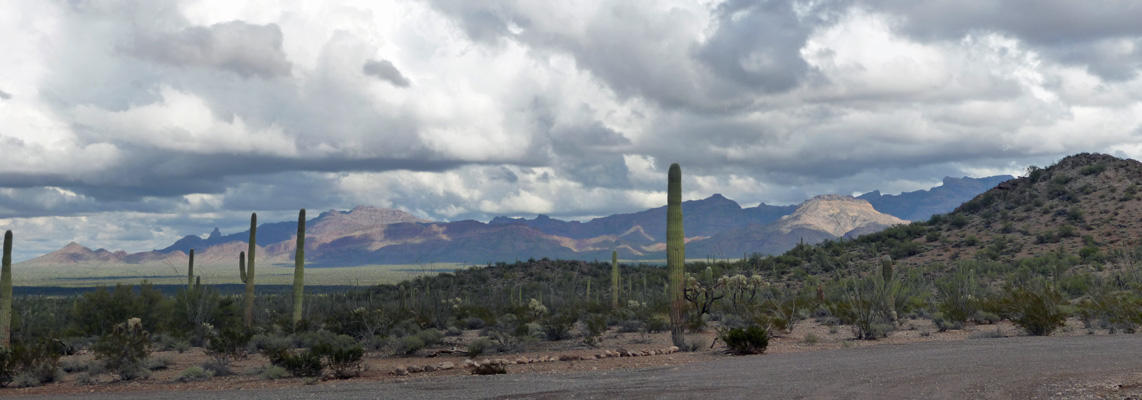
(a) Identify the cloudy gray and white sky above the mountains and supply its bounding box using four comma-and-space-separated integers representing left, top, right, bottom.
0, 0, 1142, 261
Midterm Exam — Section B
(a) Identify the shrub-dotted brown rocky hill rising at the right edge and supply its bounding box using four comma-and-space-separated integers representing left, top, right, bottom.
830, 153, 1142, 267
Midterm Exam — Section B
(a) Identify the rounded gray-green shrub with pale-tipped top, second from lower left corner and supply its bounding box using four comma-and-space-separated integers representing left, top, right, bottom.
95, 318, 151, 381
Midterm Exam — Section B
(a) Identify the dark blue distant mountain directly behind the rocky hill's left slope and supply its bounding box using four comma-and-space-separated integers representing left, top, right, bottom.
857, 175, 1015, 221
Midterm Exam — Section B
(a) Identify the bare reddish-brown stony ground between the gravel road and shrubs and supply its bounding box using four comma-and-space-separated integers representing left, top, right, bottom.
0, 319, 1142, 398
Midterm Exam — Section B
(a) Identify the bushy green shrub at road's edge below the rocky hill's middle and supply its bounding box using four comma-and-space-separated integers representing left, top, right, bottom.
990, 282, 1067, 336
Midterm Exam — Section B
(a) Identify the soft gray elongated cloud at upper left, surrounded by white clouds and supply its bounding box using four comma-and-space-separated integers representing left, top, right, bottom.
127, 21, 290, 78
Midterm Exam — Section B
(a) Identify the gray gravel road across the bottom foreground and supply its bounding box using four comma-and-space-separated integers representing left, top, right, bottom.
17, 335, 1142, 400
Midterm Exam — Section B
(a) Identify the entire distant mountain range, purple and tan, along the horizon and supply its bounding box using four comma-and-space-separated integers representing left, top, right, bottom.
23, 176, 1011, 267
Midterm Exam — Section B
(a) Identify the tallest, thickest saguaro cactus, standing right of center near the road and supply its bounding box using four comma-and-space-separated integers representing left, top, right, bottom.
666, 163, 686, 347
